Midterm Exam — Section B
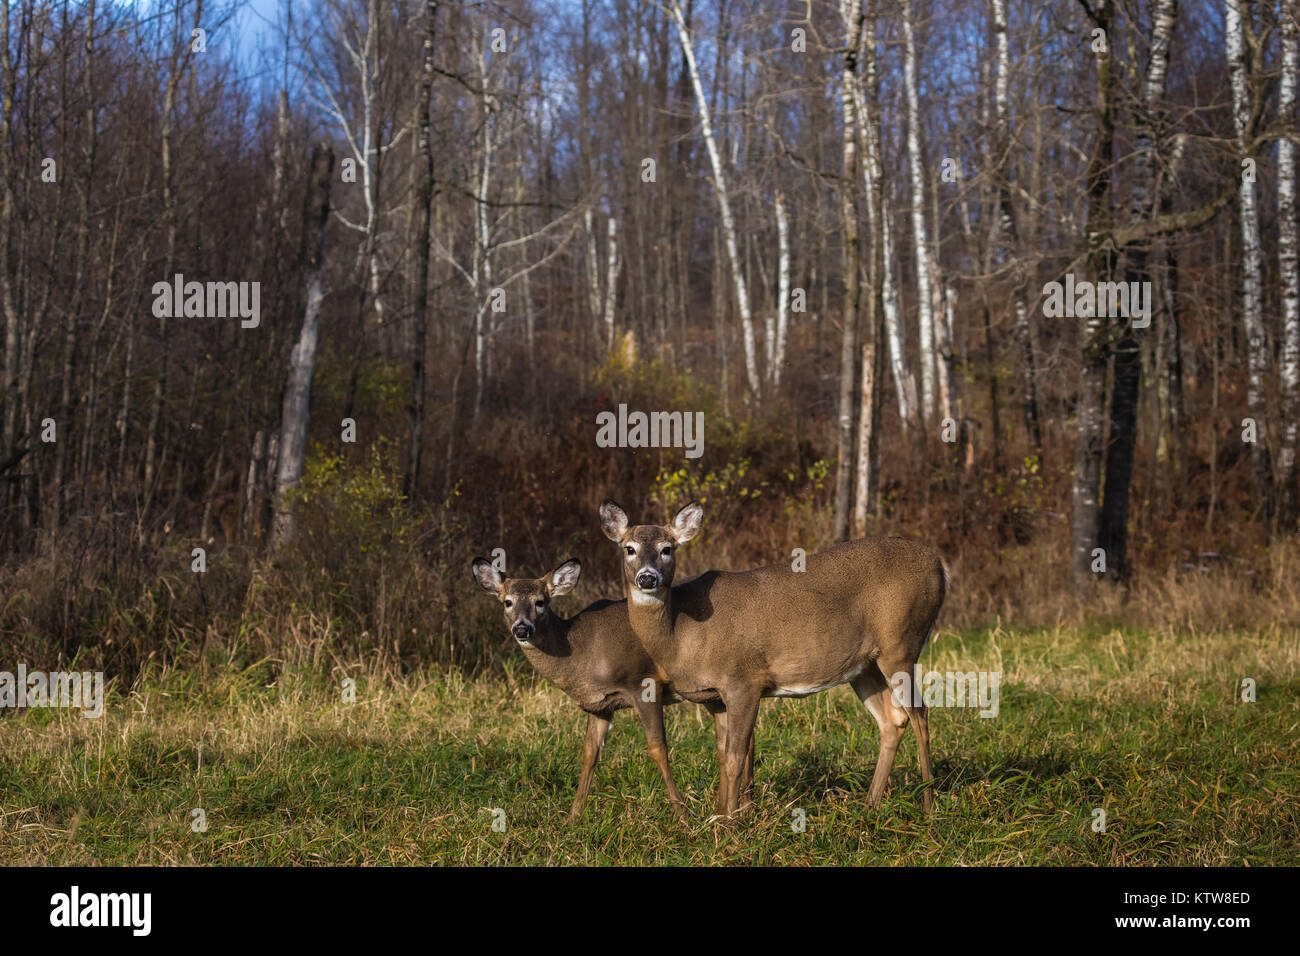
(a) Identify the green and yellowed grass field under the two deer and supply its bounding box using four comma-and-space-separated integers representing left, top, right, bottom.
0, 628, 1300, 866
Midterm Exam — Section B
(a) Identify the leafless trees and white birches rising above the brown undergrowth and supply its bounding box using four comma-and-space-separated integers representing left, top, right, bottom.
0, 0, 1300, 598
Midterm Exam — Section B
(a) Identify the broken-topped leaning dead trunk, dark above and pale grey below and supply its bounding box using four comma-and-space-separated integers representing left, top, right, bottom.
270, 143, 334, 550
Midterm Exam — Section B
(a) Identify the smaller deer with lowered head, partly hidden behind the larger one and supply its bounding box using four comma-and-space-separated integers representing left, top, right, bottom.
472, 558, 686, 822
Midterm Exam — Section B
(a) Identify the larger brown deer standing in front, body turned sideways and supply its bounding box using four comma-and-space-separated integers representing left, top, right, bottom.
601, 501, 948, 816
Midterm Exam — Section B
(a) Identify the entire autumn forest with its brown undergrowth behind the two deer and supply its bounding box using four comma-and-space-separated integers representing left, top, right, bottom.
0, 0, 1300, 682
